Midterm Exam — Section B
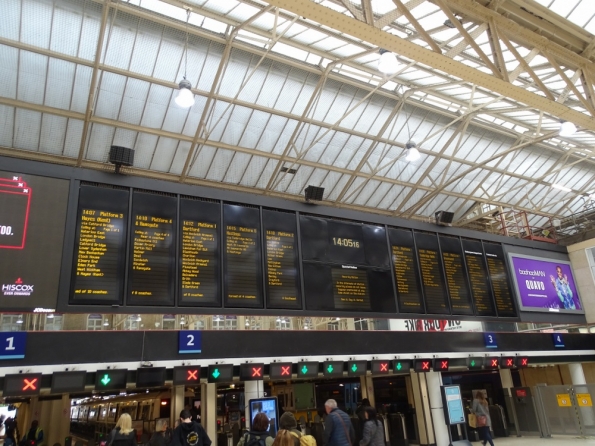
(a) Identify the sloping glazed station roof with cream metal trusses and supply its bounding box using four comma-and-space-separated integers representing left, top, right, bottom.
0, 0, 595, 233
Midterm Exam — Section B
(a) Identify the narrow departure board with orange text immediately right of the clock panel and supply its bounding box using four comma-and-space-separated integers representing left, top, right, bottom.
388, 228, 426, 313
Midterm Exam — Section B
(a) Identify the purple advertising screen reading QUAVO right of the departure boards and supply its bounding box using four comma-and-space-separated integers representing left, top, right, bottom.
508, 253, 584, 314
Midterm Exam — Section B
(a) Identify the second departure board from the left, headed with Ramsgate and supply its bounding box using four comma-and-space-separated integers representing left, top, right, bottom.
127, 191, 178, 305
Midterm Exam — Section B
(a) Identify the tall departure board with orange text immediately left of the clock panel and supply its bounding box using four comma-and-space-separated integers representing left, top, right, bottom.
262, 209, 302, 309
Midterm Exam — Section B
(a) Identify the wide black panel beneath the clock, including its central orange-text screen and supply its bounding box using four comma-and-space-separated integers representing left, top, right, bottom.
303, 262, 396, 312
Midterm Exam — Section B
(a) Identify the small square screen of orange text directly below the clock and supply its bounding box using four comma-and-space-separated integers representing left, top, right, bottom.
331, 268, 370, 310
